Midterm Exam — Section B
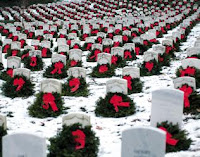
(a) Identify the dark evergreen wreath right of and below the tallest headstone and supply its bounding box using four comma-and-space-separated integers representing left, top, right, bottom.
157, 121, 192, 153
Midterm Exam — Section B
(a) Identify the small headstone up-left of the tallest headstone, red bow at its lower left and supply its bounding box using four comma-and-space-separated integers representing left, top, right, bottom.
122, 67, 140, 78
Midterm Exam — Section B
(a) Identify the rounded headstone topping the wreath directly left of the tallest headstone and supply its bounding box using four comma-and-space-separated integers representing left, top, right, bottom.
106, 79, 128, 94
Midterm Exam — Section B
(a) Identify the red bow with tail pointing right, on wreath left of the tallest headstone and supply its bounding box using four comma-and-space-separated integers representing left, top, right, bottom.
110, 94, 130, 112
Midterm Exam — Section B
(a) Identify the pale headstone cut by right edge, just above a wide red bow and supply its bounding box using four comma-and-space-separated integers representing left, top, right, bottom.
182, 58, 200, 69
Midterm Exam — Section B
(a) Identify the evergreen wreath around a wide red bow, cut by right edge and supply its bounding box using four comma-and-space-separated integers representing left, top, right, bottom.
176, 66, 200, 88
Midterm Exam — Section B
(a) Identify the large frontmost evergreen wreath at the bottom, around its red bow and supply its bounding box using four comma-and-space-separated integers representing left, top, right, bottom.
48, 123, 99, 157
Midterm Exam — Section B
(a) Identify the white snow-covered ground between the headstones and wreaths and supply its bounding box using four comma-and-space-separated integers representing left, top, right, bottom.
0, 18, 200, 157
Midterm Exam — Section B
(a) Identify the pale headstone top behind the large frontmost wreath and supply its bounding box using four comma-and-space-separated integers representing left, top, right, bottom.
62, 113, 91, 127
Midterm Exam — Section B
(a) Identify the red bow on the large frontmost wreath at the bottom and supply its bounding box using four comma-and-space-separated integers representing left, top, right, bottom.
72, 130, 85, 150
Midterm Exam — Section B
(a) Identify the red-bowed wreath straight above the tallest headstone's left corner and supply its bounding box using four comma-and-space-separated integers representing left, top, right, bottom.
140, 59, 161, 76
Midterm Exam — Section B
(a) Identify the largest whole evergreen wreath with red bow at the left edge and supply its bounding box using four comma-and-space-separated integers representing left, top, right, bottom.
2, 75, 34, 98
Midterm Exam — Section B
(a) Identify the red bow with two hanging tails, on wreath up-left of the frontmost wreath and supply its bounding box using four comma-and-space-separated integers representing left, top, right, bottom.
42, 93, 58, 112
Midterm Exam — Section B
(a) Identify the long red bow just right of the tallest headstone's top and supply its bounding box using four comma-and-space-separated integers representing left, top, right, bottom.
179, 85, 193, 108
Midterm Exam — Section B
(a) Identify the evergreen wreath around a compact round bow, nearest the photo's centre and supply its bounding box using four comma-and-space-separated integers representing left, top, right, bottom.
90, 64, 115, 78
